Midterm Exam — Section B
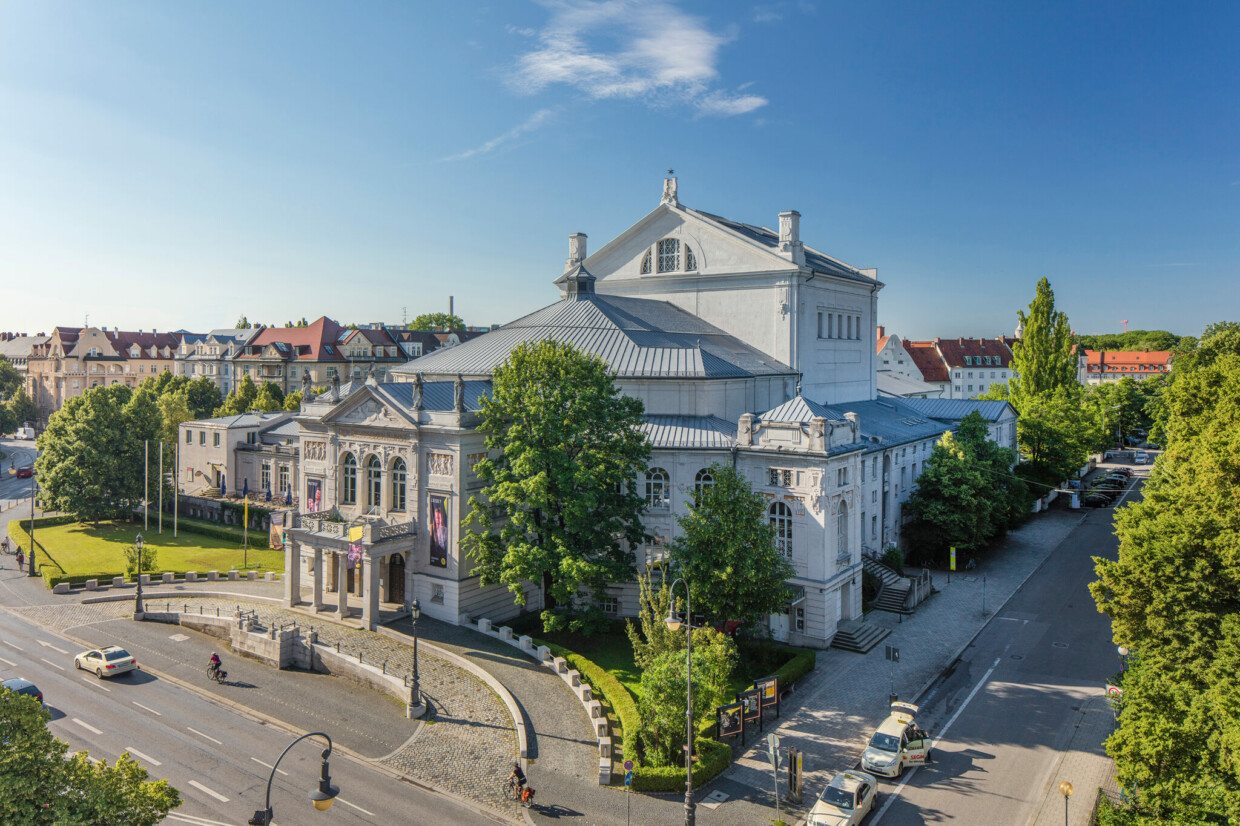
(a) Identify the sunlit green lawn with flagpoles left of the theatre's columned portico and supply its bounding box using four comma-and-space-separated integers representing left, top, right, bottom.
9, 520, 284, 580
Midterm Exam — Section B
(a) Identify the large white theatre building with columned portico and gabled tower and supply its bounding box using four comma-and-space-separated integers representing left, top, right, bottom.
286, 179, 946, 646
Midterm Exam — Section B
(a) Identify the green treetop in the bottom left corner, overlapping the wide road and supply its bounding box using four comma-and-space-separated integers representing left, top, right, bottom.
0, 690, 181, 826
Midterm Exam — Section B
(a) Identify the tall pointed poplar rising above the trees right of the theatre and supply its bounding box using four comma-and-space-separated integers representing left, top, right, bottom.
1008, 278, 1076, 417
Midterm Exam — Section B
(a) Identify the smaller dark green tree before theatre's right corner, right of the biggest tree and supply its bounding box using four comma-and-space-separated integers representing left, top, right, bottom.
670, 464, 795, 626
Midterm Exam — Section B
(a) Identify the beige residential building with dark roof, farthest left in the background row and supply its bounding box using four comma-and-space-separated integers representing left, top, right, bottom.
26, 327, 180, 425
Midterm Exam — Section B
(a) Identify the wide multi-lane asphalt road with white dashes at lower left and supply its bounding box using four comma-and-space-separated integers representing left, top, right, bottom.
0, 611, 494, 826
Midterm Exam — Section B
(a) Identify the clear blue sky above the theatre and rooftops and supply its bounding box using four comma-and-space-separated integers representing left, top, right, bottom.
0, 0, 1240, 337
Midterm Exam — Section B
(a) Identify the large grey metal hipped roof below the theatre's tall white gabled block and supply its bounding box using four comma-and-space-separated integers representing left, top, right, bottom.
392, 294, 792, 378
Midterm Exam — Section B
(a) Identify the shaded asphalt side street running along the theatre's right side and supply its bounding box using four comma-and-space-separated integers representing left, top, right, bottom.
868, 473, 1132, 826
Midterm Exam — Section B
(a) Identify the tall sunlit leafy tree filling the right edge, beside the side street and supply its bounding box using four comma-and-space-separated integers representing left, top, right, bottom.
1090, 349, 1240, 824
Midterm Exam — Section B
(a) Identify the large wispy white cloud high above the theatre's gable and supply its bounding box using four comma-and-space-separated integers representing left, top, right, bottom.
510, 0, 766, 115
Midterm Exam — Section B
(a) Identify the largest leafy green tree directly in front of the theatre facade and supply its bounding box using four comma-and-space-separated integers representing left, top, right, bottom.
461, 341, 650, 631
